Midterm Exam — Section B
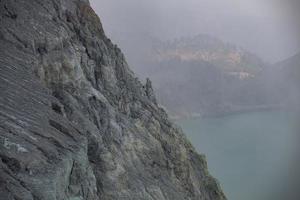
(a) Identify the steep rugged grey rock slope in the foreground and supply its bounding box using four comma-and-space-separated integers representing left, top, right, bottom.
0, 0, 225, 200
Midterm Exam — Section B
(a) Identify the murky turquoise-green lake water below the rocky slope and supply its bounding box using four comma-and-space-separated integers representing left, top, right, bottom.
177, 111, 300, 200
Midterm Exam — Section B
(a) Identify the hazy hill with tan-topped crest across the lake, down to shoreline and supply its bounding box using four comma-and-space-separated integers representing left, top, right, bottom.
137, 35, 271, 117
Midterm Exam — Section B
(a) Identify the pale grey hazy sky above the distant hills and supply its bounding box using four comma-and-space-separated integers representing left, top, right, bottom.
90, 0, 300, 62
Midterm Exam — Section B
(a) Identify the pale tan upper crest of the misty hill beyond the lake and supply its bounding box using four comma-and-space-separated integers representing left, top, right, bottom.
152, 34, 265, 76
